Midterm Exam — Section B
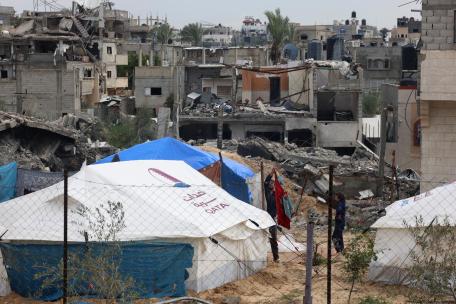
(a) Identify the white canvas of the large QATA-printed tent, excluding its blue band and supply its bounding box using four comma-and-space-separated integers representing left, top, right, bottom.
0, 161, 274, 292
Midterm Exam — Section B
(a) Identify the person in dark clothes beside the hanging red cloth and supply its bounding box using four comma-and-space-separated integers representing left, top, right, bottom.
264, 169, 280, 263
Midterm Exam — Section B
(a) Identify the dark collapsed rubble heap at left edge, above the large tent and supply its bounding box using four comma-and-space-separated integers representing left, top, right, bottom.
0, 112, 116, 172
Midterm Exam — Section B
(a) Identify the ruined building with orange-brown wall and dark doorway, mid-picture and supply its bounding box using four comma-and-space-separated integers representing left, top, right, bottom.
179, 61, 362, 148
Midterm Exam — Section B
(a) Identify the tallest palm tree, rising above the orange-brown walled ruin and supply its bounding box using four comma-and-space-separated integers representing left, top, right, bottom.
264, 8, 294, 65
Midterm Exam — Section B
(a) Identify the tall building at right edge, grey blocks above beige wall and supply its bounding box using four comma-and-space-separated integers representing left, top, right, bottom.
420, 0, 456, 192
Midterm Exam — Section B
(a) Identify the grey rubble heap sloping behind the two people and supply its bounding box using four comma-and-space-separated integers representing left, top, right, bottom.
237, 137, 419, 198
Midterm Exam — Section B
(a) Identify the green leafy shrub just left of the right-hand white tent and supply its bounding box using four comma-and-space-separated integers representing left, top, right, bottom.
343, 234, 377, 303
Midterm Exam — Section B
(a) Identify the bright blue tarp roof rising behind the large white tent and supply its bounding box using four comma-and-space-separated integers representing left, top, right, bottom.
96, 137, 255, 203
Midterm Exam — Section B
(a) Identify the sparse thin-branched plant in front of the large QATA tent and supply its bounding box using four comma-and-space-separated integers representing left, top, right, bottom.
35, 201, 138, 303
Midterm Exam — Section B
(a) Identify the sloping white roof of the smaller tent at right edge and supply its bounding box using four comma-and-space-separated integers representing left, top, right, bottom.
372, 182, 456, 228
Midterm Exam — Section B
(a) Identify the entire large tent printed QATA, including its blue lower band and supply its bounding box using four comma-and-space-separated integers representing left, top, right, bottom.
0, 162, 274, 300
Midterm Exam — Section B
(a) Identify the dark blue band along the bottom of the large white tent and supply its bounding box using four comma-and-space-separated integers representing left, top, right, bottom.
0, 242, 194, 301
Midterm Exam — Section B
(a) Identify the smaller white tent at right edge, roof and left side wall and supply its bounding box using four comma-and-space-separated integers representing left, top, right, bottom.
369, 183, 456, 284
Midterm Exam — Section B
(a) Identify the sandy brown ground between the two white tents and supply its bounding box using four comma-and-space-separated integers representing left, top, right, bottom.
0, 147, 409, 304
